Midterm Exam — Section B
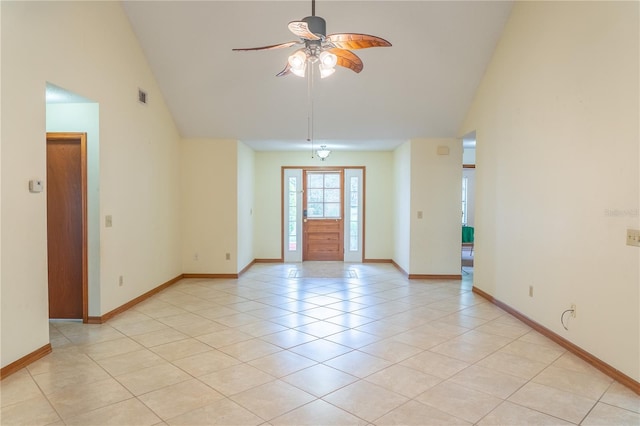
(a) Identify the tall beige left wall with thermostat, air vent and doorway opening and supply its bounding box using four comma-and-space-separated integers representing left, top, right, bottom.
0, 2, 182, 366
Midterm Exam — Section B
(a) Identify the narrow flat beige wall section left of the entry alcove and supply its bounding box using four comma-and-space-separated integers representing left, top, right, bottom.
181, 139, 239, 274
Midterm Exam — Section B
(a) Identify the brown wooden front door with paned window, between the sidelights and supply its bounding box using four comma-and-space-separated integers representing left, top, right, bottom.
302, 170, 344, 261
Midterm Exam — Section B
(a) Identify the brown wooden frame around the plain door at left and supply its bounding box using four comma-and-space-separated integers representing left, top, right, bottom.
46, 132, 89, 324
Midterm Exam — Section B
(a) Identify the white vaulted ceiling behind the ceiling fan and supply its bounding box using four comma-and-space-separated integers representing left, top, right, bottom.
123, 0, 511, 150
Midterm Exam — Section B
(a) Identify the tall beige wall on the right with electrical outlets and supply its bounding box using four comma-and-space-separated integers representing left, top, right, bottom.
461, 2, 640, 380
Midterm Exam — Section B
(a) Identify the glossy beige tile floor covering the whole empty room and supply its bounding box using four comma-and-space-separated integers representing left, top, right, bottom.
0, 263, 640, 426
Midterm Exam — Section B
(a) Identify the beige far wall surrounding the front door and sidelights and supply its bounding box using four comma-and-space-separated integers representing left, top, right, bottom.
254, 151, 394, 259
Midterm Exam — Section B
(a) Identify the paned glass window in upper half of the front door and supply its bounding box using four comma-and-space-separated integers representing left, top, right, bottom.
307, 172, 342, 219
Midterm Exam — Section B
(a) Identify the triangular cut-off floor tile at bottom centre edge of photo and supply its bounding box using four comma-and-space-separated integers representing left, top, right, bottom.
269, 400, 368, 426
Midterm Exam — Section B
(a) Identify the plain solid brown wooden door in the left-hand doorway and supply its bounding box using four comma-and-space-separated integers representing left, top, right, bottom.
46, 133, 87, 321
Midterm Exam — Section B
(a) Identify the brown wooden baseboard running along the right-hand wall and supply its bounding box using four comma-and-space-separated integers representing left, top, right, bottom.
472, 286, 640, 395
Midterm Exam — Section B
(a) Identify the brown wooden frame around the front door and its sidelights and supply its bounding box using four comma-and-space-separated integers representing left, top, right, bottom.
280, 166, 367, 263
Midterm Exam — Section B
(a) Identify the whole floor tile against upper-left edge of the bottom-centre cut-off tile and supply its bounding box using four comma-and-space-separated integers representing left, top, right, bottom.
231, 380, 315, 420
